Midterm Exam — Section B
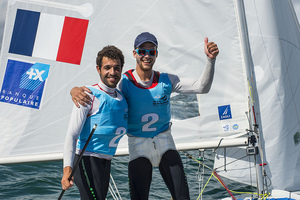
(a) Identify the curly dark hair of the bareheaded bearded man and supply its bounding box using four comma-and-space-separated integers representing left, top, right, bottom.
96, 45, 124, 68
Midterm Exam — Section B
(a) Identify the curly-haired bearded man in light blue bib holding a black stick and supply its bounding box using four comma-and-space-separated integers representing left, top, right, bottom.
61, 46, 128, 200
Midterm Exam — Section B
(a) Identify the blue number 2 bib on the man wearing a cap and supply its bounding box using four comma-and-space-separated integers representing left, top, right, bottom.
122, 70, 172, 138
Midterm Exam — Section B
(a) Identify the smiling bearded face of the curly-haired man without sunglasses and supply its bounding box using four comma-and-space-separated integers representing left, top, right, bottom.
97, 57, 122, 88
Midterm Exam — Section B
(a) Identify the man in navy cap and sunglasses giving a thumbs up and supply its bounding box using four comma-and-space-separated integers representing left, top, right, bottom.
71, 32, 219, 200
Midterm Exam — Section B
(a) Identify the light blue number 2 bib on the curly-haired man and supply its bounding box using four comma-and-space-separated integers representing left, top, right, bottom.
77, 87, 128, 155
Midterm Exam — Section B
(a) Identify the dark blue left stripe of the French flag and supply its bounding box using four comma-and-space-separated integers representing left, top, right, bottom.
9, 9, 40, 56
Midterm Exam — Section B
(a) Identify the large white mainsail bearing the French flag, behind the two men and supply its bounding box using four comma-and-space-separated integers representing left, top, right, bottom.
0, 0, 248, 163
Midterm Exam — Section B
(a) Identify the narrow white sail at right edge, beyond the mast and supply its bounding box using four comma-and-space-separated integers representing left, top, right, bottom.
249, 1, 300, 191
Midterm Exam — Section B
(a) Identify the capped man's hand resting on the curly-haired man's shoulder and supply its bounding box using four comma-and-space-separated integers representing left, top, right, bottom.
70, 86, 92, 108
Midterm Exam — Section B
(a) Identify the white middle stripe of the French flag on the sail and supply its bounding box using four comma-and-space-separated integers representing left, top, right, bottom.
32, 13, 65, 60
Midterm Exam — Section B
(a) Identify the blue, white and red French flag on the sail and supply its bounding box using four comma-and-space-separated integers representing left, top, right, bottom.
9, 9, 89, 65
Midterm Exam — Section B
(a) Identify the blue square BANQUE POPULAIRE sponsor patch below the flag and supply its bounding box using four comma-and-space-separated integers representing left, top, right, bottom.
0, 60, 50, 109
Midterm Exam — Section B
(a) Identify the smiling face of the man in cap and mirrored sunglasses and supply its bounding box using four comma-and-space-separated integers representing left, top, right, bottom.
133, 42, 157, 72
